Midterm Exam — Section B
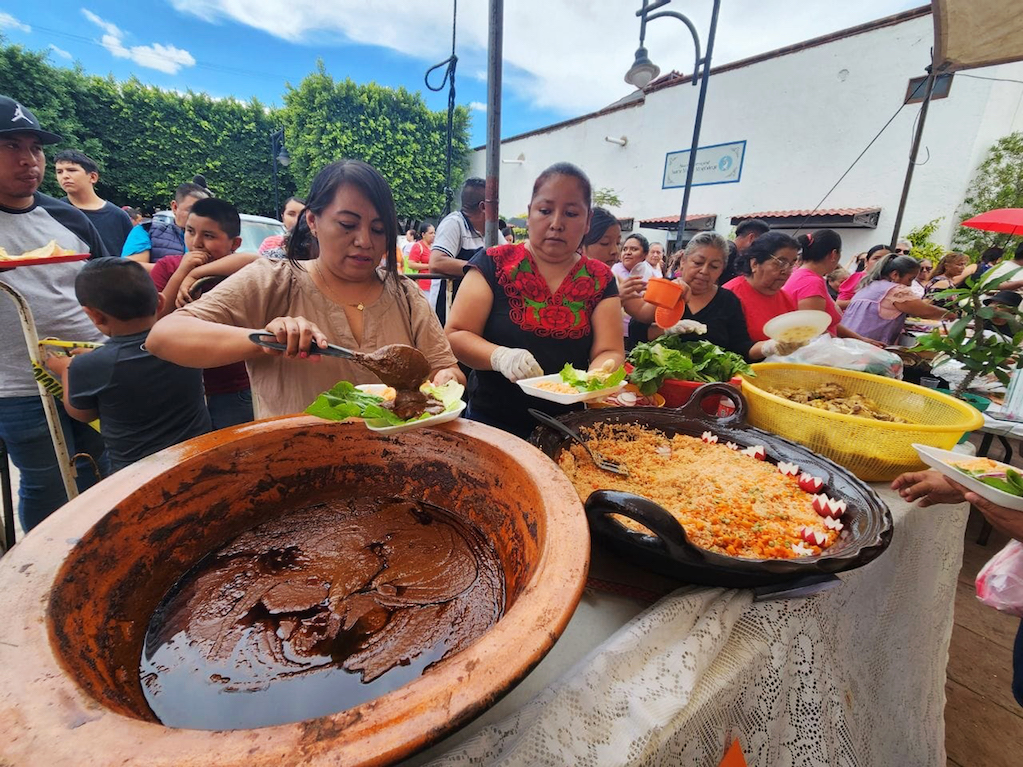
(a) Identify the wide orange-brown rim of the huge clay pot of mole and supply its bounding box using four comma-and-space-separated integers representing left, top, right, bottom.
0, 415, 589, 765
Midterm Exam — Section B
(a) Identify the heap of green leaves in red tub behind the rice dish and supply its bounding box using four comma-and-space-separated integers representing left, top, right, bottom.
628, 335, 755, 395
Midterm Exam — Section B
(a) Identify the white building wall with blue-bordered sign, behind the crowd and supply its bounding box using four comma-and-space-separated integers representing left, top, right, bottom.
472, 10, 1023, 254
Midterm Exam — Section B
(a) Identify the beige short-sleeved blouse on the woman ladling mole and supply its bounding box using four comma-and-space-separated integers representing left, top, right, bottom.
178, 259, 456, 418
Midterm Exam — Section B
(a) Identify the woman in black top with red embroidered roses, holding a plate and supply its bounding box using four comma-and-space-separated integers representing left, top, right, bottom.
446, 163, 625, 439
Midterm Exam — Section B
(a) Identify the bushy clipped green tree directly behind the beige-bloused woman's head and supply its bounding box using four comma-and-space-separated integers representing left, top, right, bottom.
281, 62, 469, 219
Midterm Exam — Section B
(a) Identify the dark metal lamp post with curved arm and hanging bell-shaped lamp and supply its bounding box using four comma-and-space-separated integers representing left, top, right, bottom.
625, 0, 721, 250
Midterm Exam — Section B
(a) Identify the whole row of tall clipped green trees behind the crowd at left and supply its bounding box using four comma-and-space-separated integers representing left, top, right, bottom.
0, 38, 470, 218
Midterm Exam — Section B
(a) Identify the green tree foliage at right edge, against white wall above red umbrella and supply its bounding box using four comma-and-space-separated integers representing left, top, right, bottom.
952, 132, 1023, 257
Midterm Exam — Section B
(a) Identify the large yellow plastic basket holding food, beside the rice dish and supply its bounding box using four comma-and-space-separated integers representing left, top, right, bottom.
743, 362, 984, 482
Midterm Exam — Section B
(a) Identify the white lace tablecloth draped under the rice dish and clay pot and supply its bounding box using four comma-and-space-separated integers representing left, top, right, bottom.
407, 486, 968, 767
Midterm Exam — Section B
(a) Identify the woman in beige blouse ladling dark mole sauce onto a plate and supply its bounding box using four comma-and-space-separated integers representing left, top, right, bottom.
146, 160, 464, 417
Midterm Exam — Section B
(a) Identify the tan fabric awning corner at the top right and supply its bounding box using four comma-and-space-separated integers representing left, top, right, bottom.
931, 0, 1023, 73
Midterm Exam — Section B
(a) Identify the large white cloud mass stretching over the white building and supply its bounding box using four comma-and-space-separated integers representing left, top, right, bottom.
165, 0, 920, 116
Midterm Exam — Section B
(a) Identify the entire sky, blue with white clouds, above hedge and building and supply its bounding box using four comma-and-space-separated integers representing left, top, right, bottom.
0, 0, 921, 145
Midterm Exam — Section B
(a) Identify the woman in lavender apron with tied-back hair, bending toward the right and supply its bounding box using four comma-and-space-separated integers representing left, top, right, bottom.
842, 254, 953, 346
